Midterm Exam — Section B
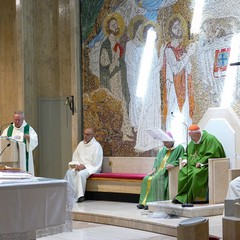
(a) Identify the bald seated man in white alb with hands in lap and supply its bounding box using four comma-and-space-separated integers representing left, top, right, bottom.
65, 128, 103, 202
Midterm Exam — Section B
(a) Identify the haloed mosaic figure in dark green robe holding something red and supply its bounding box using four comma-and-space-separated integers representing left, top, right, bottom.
99, 12, 133, 141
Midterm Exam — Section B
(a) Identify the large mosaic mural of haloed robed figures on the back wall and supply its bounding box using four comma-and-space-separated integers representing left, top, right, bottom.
81, 0, 240, 156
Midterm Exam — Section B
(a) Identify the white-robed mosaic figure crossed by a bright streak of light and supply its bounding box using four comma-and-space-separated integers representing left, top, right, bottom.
129, 21, 163, 152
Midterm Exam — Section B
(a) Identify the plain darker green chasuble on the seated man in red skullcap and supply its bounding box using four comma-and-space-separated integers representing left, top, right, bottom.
175, 130, 225, 203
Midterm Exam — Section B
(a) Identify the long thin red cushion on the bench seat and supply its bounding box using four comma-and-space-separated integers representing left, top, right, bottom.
89, 173, 146, 180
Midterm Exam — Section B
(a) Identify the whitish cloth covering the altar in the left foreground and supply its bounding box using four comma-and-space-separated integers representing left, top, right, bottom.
0, 178, 72, 240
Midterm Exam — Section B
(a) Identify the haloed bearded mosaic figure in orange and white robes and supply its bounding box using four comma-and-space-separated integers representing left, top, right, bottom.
162, 14, 196, 146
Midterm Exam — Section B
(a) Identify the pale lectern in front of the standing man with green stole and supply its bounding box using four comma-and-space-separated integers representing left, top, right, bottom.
0, 137, 26, 171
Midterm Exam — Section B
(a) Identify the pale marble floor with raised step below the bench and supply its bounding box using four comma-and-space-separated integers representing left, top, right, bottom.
38, 200, 223, 240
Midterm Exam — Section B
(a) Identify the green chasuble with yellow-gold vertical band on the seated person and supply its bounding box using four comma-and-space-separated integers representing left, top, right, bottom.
139, 145, 184, 205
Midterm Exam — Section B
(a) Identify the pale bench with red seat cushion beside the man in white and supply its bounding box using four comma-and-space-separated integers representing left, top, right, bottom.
86, 157, 155, 194
